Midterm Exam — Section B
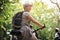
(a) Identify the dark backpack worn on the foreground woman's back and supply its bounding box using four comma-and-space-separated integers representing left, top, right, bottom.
12, 12, 23, 26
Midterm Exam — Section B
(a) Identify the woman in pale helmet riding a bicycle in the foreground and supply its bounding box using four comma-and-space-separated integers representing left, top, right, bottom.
11, 3, 44, 40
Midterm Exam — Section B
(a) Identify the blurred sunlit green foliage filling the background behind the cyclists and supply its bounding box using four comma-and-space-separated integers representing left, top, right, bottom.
0, 0, 60, 40
